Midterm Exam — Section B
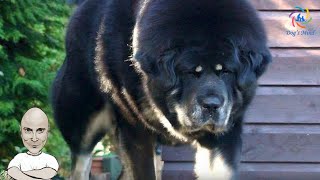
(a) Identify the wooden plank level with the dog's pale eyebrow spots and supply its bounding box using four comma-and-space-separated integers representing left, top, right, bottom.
259, 50, 320, 85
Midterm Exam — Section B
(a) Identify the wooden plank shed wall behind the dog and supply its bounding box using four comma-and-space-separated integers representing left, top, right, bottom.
161, 0, 320, 180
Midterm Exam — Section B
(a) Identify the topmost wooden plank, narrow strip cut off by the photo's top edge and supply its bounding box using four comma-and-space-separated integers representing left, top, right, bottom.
250, 0, 320, 10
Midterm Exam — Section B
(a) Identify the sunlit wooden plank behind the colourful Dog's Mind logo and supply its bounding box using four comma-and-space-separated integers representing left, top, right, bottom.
259, 12, 320, 48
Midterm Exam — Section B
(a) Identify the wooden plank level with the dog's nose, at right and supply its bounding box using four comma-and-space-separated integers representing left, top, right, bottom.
244, 93, 320, 124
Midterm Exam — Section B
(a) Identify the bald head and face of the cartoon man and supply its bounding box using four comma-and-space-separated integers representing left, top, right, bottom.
20, 108, 49, 155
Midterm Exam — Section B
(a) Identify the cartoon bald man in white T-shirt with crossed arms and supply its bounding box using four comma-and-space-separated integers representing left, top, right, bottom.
7, 108, 59, 180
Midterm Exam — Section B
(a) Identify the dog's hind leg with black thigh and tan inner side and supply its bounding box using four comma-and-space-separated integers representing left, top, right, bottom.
52, 61, 113, 180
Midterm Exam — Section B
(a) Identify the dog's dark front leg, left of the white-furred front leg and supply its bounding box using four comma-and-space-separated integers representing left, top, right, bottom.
117, 127, 156, 180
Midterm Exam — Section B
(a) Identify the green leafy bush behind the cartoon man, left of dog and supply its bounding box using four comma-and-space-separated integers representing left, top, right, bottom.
0, 0, 71, 176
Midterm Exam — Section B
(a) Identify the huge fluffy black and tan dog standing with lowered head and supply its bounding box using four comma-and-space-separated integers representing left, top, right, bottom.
52, 0, 271, 180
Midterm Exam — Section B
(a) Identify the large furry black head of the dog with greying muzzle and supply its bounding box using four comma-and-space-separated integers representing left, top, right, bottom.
134, 0, 271, 134
